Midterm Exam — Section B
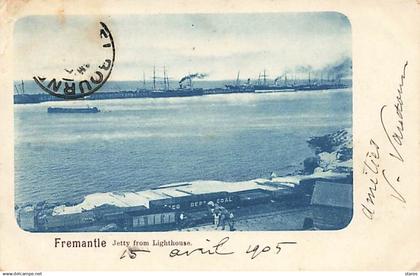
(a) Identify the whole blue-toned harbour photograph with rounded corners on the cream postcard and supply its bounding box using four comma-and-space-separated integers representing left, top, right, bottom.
13, 12, 353, 232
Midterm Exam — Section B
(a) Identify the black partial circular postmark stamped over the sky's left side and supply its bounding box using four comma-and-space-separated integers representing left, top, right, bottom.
33, 22, 115, 99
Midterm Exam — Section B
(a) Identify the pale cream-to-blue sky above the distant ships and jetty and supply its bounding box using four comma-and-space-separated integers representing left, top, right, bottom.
14, 12, 351, 80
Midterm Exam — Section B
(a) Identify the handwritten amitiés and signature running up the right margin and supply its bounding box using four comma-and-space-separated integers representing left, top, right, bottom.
361, 61, 408, 220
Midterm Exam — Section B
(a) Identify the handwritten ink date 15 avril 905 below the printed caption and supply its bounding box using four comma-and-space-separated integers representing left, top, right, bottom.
120, 237, 297, 260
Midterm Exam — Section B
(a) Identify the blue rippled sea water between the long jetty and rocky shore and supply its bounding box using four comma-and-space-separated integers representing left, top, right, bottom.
15, 88, 352, 205
